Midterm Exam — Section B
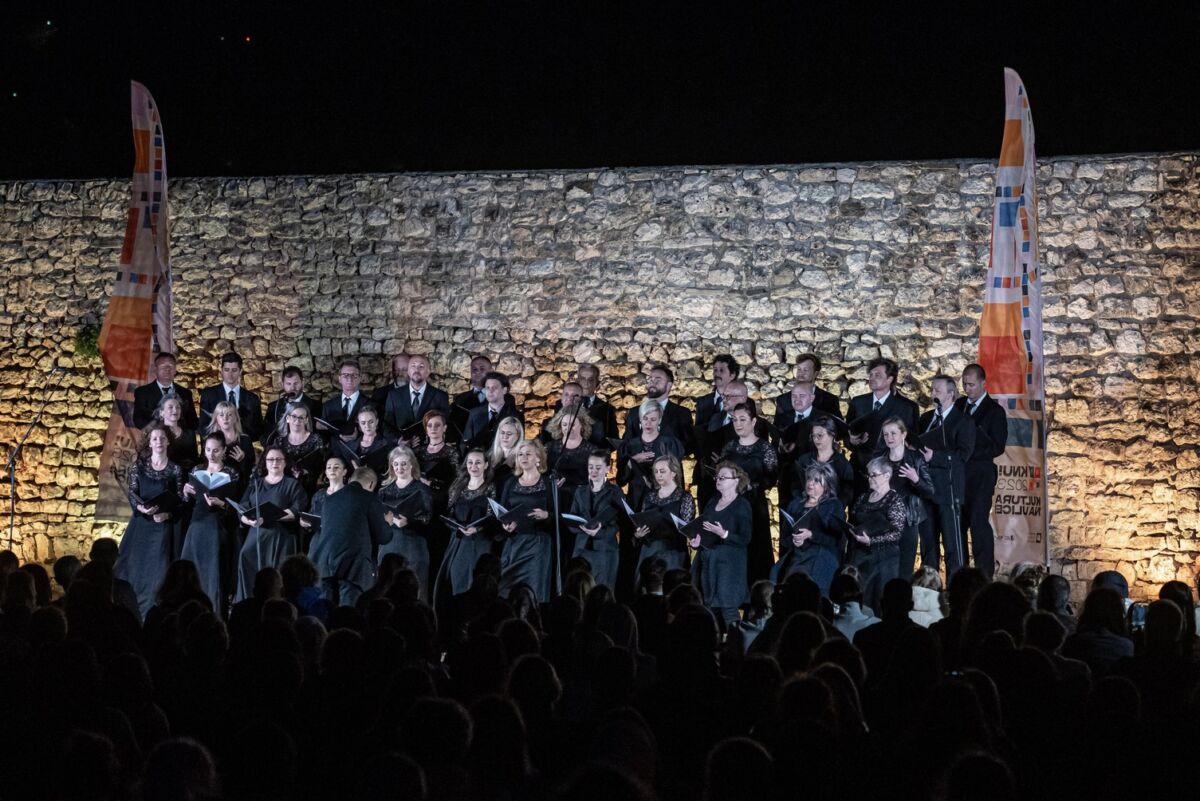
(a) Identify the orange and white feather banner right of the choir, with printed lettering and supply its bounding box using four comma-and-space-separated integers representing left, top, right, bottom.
979, 70, 1049, 566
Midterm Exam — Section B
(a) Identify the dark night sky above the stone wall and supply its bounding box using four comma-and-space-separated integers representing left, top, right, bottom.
0, 0, 1200, 179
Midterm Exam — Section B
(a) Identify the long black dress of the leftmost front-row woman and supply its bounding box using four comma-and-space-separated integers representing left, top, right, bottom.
113, 459, 184, 619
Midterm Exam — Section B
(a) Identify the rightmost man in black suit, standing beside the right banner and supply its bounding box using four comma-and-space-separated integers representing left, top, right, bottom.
958, 365, 1008, 578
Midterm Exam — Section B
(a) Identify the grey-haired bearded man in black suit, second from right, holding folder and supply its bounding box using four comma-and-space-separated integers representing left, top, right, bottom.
917, 375, 976, 579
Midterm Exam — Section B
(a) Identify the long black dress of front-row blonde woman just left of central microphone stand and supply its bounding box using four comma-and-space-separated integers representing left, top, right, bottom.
500, 476, 554, 603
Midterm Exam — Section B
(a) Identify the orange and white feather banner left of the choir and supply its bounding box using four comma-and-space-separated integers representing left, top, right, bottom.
96, 82, 175, 520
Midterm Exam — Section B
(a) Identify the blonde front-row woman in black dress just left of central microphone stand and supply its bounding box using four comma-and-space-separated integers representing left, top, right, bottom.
500, 440, 556, 603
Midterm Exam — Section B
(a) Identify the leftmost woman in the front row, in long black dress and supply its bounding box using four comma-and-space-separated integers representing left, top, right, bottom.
113, 423, 184, 618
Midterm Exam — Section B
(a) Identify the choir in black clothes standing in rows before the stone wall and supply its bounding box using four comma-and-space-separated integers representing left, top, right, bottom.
115, 353, 1008, 626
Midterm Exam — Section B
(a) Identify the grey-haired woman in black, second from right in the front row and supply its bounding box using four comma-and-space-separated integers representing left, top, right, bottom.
770, 462, 846, 597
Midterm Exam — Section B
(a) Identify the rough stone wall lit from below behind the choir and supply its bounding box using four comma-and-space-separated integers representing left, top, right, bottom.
0, 152, 1200, 594
